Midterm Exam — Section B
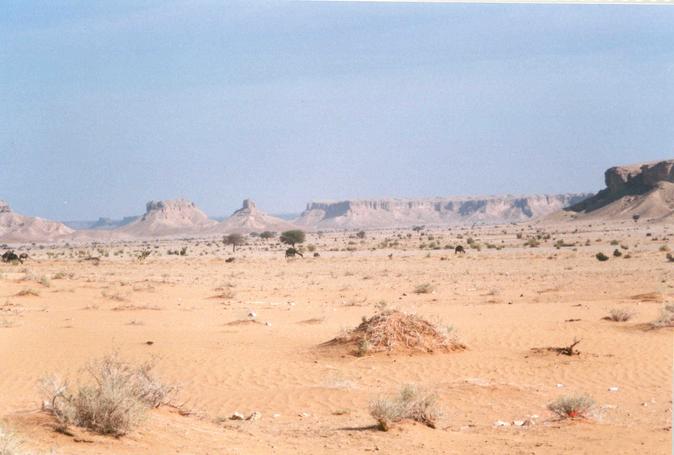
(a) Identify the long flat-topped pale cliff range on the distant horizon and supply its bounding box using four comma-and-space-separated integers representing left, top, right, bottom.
295, 194, 590, 229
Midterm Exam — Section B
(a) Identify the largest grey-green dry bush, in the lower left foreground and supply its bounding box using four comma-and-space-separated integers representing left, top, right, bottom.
41, 354, 175, 436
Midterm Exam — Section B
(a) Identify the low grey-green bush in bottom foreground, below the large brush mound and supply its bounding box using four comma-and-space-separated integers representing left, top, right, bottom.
370, 385, 440, 431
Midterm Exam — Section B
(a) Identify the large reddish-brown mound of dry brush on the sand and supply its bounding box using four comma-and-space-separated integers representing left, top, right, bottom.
329, 310, 465, 356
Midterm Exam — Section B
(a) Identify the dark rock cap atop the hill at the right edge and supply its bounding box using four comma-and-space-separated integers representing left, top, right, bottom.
604, 160, 674, 194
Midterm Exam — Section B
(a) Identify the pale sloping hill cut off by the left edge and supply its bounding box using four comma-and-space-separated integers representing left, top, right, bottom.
0, 201, 73, 243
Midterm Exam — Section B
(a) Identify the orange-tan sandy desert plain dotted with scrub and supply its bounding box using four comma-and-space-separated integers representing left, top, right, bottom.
0, 223, 674, 454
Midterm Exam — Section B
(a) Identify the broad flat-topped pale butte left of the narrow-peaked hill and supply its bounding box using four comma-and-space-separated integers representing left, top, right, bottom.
116, 199, 217, 237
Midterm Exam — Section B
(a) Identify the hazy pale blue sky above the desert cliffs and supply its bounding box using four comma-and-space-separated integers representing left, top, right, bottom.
0, 0, 674, 220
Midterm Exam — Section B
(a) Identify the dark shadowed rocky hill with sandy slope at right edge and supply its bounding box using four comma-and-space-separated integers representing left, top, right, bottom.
565, 160, 674, 220
